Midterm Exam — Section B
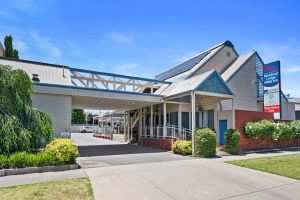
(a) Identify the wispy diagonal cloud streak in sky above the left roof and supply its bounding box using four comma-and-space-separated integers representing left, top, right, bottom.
30, 30, 62, 57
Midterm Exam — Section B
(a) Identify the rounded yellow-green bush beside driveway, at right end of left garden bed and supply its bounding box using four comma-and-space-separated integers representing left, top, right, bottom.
45, 138, 78, 163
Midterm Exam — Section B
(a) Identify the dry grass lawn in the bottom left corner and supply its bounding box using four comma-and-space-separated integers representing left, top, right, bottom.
0, 178, 93, 200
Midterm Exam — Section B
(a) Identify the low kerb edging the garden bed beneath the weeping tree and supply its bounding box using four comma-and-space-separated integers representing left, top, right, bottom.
0, 163, 80, 177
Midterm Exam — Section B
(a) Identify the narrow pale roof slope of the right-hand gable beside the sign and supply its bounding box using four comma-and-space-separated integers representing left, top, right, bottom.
221, 51, 256, 82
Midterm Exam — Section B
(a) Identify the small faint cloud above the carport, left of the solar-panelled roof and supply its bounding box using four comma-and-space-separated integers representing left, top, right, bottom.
107, 30, 135, 44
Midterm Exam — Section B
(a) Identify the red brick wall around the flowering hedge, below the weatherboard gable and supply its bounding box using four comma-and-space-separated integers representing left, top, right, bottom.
235, 110, 300, 150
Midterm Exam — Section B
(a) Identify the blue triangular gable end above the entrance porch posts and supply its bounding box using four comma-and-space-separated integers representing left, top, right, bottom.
196, 71, 233, 95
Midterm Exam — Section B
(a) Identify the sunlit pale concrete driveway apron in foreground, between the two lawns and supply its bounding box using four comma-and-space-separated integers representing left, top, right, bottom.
85, 159, 300, 200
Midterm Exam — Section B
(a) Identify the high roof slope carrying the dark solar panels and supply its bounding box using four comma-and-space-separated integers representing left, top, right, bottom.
155, 40, 234, 80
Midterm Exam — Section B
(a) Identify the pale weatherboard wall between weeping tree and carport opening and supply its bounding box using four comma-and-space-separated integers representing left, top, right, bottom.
32, 93, 72, 136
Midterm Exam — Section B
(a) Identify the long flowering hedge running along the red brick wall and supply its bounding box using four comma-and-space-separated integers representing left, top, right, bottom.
244, 120, 300, 140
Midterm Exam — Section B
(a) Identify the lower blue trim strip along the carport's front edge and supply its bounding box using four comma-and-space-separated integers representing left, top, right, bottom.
34, 83, 163, 97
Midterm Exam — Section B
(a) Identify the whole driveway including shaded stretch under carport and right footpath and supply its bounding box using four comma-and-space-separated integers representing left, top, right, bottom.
71, 134, 300, 200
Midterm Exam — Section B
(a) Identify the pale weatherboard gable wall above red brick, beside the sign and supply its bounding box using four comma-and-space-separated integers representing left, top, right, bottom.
227, 56, 257, 111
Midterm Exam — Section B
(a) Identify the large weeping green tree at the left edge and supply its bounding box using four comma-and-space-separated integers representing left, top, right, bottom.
0, 65, 53, 155
